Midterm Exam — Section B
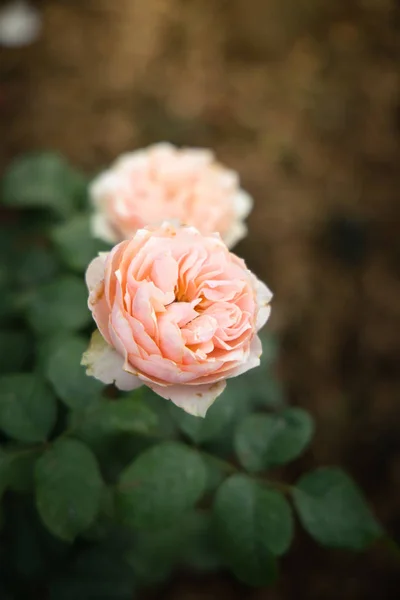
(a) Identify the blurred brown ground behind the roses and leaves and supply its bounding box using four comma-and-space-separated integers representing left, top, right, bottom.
0, 0, 400, 600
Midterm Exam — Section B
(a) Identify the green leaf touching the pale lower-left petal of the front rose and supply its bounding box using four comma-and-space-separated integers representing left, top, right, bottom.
44, 336, 104, 409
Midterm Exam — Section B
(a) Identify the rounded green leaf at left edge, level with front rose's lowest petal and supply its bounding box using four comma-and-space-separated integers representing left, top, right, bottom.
0, 373, 57, 442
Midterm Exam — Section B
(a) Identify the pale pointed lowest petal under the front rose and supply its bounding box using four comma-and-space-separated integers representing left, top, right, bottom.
149, 380, 226, 417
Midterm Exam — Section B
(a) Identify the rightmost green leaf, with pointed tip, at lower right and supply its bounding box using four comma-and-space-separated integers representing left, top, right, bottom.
293, 467, 382, 550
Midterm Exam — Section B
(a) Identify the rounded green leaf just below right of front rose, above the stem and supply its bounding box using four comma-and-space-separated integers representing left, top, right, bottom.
235, 408, 314, 472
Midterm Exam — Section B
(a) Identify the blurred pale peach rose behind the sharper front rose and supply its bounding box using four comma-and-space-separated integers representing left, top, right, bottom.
90, 143, 252, 248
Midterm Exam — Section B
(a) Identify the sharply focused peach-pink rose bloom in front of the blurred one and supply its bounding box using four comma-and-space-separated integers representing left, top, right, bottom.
82, 223, 272, 416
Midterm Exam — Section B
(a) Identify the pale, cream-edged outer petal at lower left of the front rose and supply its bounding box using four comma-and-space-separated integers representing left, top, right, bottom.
81, 331, 143, 391
